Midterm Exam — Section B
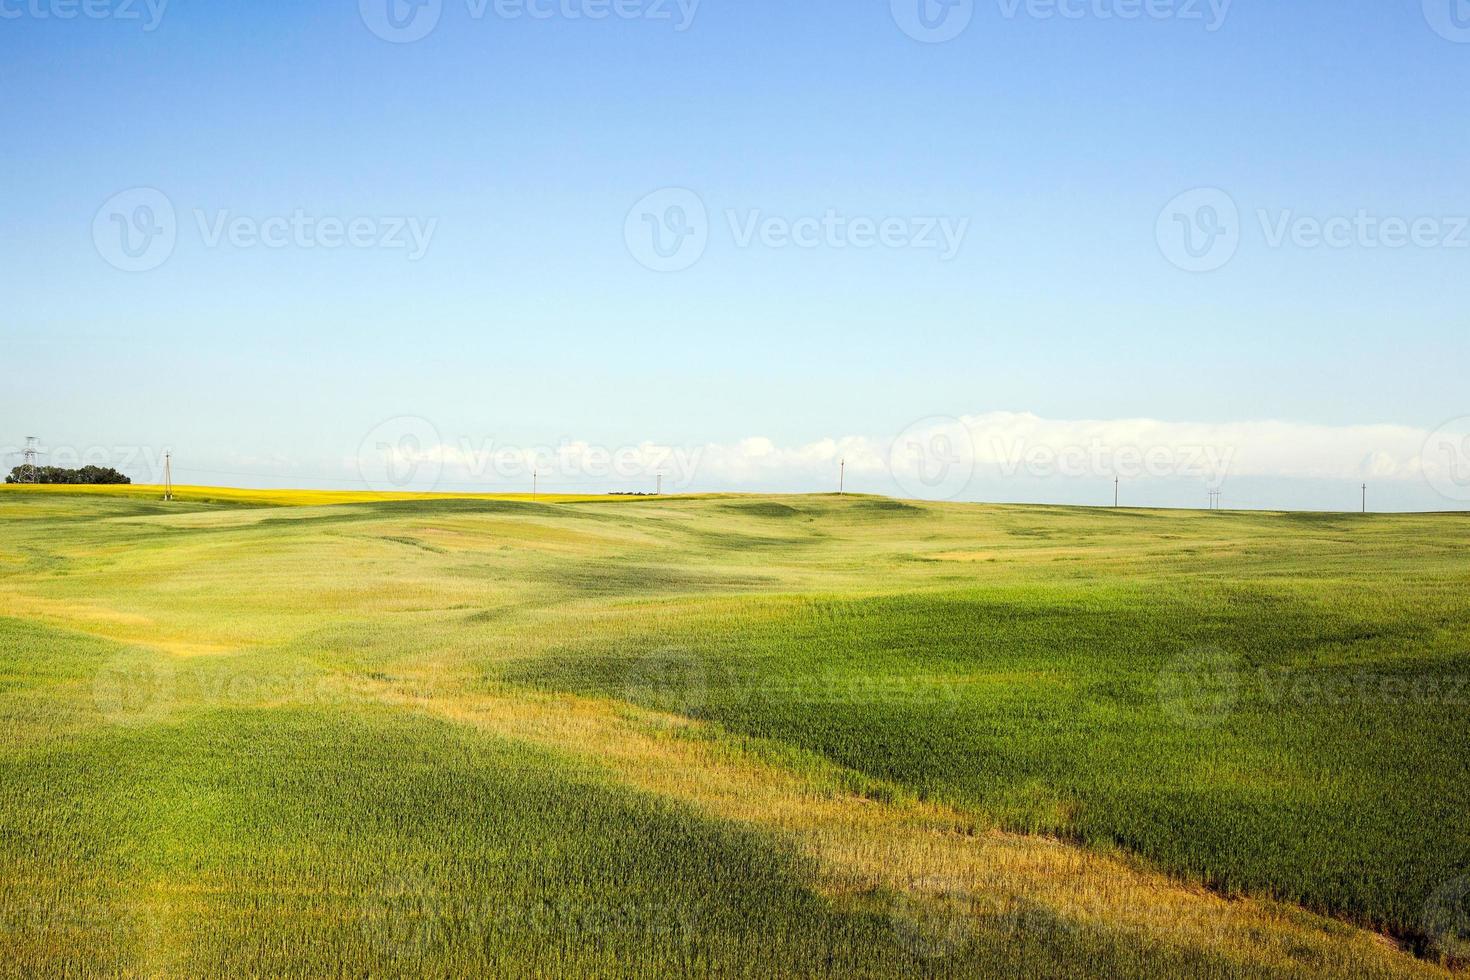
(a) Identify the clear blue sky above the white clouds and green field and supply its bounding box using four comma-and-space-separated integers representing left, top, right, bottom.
0, 0, 1470, 508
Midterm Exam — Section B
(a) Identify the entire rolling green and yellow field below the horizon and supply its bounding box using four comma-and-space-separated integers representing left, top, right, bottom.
0, 488, 1470, 977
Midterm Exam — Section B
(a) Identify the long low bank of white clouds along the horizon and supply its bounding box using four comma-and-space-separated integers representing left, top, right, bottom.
330, 411, 1470, 507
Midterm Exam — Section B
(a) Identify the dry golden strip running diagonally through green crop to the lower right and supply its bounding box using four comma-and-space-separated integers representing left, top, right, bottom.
400, 681, 1449, 977
